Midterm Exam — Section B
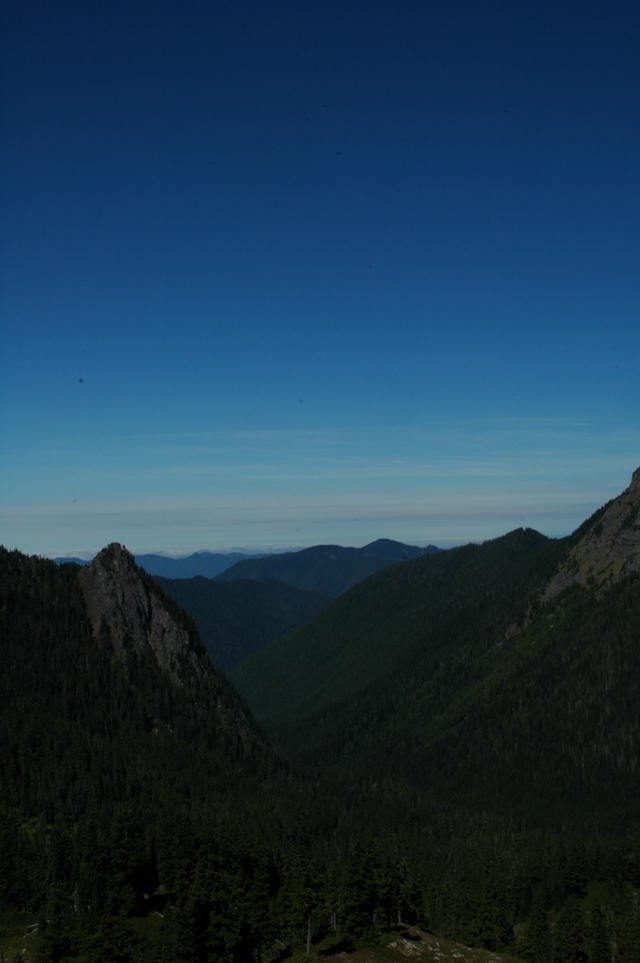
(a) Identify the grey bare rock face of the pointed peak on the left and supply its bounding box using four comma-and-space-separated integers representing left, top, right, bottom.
78, 542, 208, 686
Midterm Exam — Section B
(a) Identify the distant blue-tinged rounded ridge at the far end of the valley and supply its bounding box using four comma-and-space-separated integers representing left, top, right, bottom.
217, 538, 439, 597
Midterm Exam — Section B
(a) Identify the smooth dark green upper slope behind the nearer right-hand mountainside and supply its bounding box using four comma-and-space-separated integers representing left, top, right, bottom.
230, 529, 556, 768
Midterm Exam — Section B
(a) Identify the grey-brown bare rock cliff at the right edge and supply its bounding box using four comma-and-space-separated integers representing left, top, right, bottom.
544, 468, 640, 600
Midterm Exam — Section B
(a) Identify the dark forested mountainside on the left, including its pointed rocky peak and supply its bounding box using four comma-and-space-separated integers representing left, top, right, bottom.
0, 545, 278, 820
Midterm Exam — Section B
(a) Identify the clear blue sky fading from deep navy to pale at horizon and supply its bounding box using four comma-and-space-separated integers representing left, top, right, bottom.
0, 0, 640, 554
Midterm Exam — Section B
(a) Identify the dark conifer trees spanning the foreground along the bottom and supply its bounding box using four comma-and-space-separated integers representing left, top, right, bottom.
2, 806, 640, 963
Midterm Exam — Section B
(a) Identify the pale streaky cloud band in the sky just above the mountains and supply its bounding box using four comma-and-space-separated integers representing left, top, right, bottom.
0, 419, 640, 555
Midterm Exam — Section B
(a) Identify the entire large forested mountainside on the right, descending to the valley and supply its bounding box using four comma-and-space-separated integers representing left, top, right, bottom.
231, 473, 640, 819
